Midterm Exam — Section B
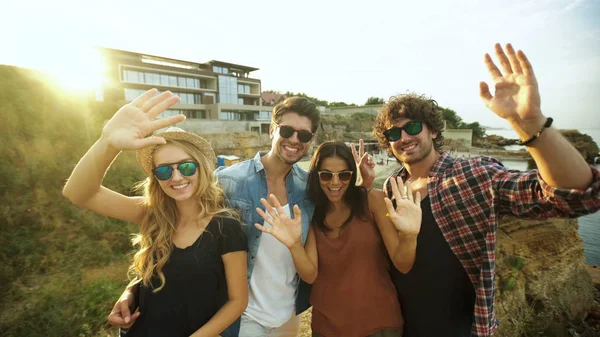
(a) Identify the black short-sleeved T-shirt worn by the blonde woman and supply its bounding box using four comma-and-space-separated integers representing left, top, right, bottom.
126, 218, 248, 337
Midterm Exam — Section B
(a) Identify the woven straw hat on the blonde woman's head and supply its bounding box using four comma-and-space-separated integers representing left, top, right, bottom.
136, 127, 217, 176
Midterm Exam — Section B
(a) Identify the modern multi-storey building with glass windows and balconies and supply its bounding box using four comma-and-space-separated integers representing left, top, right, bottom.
99, 48, 272, 134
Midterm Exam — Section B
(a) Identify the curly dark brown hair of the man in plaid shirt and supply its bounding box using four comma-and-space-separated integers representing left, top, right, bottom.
373, 93, 444, 156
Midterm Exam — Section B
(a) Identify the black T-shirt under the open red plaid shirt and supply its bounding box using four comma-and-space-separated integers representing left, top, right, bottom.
391, 197, 475, 337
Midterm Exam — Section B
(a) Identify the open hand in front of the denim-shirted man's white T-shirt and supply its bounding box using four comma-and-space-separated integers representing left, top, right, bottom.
254, 194, 302, 249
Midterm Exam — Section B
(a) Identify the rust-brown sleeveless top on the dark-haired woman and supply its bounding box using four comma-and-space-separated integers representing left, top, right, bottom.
310, 217, 403, 337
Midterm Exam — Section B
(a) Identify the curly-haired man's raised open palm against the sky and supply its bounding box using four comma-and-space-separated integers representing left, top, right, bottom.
479, 43, 545, 134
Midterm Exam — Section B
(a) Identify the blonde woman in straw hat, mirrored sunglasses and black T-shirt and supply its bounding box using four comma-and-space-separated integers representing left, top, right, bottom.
63, 89, 248, 336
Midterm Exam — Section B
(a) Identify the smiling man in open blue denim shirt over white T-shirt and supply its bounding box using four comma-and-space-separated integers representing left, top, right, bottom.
109, 97, 321, 337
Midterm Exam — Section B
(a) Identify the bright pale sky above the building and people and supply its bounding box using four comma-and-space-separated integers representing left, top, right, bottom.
0, 0, 600, 128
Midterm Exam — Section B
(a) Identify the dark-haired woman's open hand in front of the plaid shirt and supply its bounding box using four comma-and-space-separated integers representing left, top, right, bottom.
384, 177, 421, 236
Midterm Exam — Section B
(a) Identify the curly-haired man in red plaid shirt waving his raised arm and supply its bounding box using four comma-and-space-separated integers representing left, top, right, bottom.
374, 44, 600, 337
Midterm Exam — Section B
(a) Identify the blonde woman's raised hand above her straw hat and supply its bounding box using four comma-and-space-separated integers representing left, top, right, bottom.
102, 89, 185, 150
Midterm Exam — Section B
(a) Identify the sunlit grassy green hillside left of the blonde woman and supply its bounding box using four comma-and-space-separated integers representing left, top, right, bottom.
0, 66, 143, 337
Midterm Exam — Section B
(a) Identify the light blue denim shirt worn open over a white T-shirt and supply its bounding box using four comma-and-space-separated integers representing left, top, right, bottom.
216, 152, 315, 336
